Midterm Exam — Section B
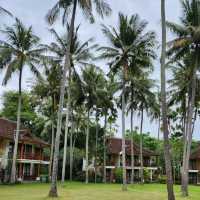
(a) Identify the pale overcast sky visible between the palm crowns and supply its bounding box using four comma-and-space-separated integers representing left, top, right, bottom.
0, 0, 200, 139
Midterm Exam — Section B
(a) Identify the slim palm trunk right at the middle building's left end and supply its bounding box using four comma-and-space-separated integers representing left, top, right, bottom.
103, 111, 107, 183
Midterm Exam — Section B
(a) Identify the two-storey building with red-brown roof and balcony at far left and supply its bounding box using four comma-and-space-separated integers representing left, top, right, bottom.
0, 118, 50, 181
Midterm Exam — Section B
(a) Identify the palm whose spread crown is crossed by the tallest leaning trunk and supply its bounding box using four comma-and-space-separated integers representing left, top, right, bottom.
43, 26, 96, 183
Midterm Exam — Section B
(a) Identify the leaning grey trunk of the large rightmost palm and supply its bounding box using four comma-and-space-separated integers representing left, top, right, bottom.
181, 55, 198, 197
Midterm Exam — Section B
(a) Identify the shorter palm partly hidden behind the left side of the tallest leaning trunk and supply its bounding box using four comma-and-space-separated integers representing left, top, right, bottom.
32, 60, 61, 178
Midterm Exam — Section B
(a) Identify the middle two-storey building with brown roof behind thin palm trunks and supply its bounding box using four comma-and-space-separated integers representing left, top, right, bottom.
106, 138, 158, 182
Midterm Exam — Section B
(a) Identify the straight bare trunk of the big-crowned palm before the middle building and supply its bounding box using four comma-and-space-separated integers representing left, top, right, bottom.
122, 72, 127, 191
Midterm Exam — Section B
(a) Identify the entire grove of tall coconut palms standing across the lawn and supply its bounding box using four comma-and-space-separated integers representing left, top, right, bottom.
0, 0, 200, 200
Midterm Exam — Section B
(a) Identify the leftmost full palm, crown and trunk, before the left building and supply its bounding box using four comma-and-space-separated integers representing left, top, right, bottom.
0, 19, 44, 183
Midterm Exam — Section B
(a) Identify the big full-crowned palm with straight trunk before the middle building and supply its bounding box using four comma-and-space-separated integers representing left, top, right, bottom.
99, 13, 155, 190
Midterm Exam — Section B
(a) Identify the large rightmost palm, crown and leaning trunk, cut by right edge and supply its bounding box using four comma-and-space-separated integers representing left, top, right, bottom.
167, 0, 200, 196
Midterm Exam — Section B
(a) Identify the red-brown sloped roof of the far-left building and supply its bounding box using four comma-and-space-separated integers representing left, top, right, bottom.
0, 118, 49, 147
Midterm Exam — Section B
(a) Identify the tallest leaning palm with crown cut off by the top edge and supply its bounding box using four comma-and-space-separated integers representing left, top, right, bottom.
46, 0, 111, 197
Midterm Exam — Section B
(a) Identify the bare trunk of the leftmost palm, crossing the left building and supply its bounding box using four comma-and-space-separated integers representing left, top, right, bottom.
10, 68, 22, 183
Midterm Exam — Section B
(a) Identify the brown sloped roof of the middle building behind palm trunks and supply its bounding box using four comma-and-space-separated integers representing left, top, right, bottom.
107, 138, 158, 157
